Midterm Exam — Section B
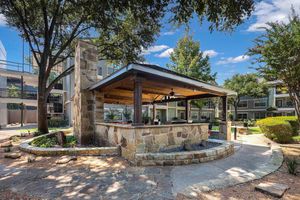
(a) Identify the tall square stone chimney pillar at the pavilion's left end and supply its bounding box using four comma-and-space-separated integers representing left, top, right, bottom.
73, 41, 98, 144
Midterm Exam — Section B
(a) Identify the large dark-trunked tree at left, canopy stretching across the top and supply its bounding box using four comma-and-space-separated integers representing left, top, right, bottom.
0, 0, 254, 132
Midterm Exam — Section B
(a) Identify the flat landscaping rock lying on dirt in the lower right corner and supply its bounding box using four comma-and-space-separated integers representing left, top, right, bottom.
255, 182, 289, 198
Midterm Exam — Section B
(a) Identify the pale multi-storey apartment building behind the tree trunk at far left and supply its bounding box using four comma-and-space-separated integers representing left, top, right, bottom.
0, 44, 66, 127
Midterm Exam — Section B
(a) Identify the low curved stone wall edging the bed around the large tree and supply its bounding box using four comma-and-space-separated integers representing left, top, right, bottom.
19, 133, 120, 156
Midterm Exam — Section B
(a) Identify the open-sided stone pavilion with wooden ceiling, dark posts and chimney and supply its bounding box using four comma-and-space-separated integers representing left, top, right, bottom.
73, 41, 236, 160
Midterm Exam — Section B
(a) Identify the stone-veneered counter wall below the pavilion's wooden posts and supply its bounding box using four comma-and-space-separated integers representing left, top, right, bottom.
95, 123, 208, 162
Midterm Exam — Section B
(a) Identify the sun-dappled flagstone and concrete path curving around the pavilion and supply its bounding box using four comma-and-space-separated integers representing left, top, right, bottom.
0, 135, 282, 200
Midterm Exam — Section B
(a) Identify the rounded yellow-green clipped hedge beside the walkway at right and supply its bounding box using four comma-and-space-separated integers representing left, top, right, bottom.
256, 116, 299, 143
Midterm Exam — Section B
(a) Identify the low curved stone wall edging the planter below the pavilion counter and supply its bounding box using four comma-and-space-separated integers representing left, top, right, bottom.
135, 139, 234, 166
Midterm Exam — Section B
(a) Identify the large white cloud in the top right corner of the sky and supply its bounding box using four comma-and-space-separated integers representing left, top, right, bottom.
247, 0, 300, 32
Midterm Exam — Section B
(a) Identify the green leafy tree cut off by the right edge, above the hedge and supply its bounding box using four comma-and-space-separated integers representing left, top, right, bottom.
249, 9, 300, 120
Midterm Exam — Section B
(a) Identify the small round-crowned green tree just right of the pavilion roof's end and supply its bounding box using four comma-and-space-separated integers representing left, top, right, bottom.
224, 74, 268, 120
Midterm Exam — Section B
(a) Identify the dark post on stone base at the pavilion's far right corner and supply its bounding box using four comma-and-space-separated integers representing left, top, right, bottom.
219, 96, 231, 141
